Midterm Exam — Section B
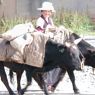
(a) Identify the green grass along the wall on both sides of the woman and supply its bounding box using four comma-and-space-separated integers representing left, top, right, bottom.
0, 11, 95, 35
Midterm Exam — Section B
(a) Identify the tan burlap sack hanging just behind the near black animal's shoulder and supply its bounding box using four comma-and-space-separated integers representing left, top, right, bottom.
24, 32, 49, 68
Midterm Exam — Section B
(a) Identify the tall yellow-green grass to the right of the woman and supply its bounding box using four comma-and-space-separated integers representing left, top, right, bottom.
54, 11, 95, 34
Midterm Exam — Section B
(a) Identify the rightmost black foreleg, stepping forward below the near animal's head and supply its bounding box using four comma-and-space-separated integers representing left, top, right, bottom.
67, 69, 79, 94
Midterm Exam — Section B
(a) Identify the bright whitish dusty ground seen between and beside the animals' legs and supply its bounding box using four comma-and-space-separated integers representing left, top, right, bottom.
0, 66, 95, 95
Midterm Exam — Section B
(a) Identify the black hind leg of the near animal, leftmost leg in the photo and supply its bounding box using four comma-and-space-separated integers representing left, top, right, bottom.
0, 63, 16, 95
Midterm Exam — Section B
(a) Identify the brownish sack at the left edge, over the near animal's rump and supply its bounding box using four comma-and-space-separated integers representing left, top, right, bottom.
0, 38, 24, 64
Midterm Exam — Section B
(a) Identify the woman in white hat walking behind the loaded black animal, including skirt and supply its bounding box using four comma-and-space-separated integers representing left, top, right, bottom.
36, 2, 61, 91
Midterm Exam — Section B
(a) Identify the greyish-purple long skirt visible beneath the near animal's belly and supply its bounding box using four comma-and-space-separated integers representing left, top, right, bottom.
43, 68, 65, 87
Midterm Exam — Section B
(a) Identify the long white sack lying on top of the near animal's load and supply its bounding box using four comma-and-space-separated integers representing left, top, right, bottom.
2, 22, 34, 41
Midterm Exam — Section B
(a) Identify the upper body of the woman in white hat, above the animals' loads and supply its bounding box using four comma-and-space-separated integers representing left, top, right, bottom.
36, 2, 55, 32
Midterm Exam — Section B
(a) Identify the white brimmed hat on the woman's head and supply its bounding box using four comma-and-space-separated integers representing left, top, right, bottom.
38, 2, 55, 12
